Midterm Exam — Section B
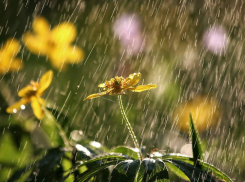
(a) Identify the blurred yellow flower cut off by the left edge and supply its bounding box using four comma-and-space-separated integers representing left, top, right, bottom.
0, 39, 23, 74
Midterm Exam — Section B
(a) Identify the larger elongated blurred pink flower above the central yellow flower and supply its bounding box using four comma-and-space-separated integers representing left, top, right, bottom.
113, 15, 144, 54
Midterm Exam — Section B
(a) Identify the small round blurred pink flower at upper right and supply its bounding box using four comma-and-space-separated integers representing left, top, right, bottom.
203, 27, 228, 54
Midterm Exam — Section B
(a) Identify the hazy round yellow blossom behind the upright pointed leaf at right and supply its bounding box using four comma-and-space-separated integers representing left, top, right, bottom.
175, 97, 219, 131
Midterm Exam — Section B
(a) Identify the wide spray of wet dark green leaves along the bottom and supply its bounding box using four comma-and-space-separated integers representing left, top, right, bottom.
7, 112, 232, 182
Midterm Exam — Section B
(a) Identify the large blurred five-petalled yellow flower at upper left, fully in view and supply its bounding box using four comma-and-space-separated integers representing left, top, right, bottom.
23, 17, 84, 70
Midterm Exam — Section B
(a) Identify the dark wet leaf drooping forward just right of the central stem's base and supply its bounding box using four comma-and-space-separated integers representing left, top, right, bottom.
135, 158, 169, 182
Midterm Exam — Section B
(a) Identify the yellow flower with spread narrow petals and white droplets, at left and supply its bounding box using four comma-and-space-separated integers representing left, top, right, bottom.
6, 71, 53, 119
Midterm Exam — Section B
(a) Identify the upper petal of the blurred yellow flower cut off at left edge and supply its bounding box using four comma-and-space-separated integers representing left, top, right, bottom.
3, 39, 20, 56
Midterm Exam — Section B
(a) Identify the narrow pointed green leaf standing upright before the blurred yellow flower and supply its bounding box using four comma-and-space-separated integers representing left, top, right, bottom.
190, 114, 203, 168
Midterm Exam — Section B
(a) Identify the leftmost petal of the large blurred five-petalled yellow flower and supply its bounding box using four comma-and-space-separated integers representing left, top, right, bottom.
22, 32, 49, 55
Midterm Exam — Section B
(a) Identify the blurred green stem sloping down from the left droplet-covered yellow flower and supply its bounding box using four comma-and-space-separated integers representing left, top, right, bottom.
44, 108, 71, 148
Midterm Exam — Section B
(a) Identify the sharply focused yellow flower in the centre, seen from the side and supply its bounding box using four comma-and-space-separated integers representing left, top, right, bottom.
84, 73, 157, 100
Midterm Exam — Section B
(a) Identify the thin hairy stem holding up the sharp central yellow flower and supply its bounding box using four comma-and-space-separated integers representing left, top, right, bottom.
118, 95, 143, 161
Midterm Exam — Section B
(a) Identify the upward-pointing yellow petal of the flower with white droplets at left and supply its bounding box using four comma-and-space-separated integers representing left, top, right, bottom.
37, 70, 53, 96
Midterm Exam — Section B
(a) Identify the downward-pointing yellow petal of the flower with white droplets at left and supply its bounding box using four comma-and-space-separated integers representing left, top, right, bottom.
31, 97, 44, 120
